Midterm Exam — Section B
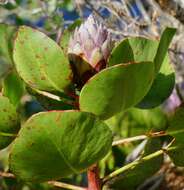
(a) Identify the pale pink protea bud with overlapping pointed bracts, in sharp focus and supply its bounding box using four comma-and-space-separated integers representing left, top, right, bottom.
68, 15, 112, 85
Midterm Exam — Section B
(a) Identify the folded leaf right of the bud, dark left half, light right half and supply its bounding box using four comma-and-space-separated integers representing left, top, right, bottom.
108, 37, 158, 66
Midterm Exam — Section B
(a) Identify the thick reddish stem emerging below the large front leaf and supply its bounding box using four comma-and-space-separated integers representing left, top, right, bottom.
87, 165, 101, 190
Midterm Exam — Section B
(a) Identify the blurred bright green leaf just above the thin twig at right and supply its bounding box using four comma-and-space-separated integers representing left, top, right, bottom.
105, 107, 167, 138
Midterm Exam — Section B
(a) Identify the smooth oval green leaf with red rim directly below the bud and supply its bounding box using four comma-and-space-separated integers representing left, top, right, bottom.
79, 62, 154, 119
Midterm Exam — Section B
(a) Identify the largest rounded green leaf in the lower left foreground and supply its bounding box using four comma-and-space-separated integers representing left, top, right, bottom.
10, 110, 112, 182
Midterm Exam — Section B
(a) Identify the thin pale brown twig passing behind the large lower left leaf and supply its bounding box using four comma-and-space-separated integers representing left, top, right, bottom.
0, 171, 87, 190
